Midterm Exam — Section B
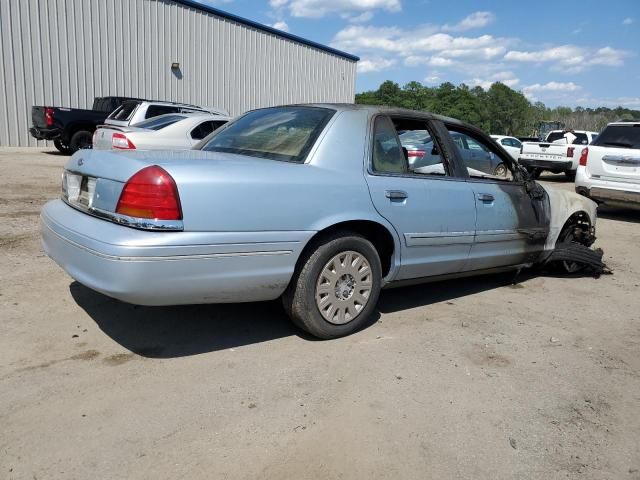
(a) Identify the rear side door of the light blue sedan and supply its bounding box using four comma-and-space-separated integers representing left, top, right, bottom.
366, 115, 476, 280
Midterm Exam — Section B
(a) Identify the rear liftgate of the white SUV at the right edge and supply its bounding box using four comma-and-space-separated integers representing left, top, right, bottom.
587, 123, 640, 183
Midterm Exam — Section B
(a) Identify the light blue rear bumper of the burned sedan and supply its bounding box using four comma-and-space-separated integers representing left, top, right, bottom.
40, 200, 315, 305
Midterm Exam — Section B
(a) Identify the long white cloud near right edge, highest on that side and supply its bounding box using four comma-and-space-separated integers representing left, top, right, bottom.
504, 45, 630, 73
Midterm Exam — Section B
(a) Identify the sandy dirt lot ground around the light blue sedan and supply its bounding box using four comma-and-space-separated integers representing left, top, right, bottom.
0, 149, 640, 480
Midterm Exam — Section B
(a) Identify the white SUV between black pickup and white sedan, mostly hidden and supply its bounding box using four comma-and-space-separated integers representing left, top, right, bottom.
104, 100, 229, 127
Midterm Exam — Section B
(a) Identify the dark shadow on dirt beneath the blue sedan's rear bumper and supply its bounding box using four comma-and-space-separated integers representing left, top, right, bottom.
69, 282, 314, 358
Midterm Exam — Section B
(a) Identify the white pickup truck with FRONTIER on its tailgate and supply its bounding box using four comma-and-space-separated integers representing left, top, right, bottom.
518, 130, 598, 180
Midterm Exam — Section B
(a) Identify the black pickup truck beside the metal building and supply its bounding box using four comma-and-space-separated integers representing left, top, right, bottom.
29, 97, 141, 154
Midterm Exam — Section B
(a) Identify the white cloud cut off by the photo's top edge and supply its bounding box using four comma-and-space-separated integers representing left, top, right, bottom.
276, 0, 402, 21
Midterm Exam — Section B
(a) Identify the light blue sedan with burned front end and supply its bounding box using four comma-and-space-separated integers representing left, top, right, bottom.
40, 104, 596, 338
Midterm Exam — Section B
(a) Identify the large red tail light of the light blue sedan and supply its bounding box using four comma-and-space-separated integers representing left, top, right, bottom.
116, 165, 182, 220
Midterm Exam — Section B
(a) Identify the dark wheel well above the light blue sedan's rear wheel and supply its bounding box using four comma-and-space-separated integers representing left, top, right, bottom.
296, 220, 395, 277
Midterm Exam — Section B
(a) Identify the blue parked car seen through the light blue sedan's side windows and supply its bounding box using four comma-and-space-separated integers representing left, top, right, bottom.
399, 130, 507, 177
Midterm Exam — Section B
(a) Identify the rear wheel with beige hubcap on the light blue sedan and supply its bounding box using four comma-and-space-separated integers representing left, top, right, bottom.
282, 232, 382, 340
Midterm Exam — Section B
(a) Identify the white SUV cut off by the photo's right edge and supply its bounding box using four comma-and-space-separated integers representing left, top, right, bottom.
576, 122, 640, 208
